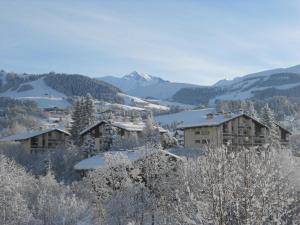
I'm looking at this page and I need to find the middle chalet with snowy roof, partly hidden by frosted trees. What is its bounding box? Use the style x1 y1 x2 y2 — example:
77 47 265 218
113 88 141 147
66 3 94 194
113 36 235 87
80 120 167 150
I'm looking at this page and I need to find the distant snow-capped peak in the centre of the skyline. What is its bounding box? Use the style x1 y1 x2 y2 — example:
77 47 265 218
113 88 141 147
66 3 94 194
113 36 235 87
98 71 199 99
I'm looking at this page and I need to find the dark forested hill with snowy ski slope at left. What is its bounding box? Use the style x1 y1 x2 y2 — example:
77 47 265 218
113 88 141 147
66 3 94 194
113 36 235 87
0 70 123 108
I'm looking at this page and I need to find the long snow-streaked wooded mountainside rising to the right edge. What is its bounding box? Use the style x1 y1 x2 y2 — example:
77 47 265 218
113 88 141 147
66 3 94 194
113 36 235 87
173 65 300 104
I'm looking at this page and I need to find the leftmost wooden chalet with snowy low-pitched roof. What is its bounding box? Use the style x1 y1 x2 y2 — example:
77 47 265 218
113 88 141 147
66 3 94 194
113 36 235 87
0 128 70 152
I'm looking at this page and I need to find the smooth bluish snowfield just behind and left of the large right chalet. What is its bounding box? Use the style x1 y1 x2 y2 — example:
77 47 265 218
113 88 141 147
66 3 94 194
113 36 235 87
155 108 216 125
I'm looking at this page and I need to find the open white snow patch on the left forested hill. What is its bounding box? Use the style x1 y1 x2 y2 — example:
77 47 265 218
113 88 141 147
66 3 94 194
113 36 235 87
0 79 70 108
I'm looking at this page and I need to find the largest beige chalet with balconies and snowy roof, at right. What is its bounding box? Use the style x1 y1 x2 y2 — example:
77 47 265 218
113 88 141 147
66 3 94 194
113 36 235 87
181 113 289 148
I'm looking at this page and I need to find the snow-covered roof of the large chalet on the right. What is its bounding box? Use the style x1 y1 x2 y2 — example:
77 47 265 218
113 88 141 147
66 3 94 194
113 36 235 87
179 113 267 129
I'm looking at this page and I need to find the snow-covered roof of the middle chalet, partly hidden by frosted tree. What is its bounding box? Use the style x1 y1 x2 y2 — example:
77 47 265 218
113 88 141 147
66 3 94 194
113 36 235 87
80 120 167 135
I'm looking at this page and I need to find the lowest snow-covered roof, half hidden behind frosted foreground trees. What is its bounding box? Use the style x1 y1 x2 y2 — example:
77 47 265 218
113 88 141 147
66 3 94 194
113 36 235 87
74 150 181 170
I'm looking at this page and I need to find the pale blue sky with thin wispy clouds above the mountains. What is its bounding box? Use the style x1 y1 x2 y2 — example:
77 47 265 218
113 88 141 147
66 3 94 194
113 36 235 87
0 0 300 85
